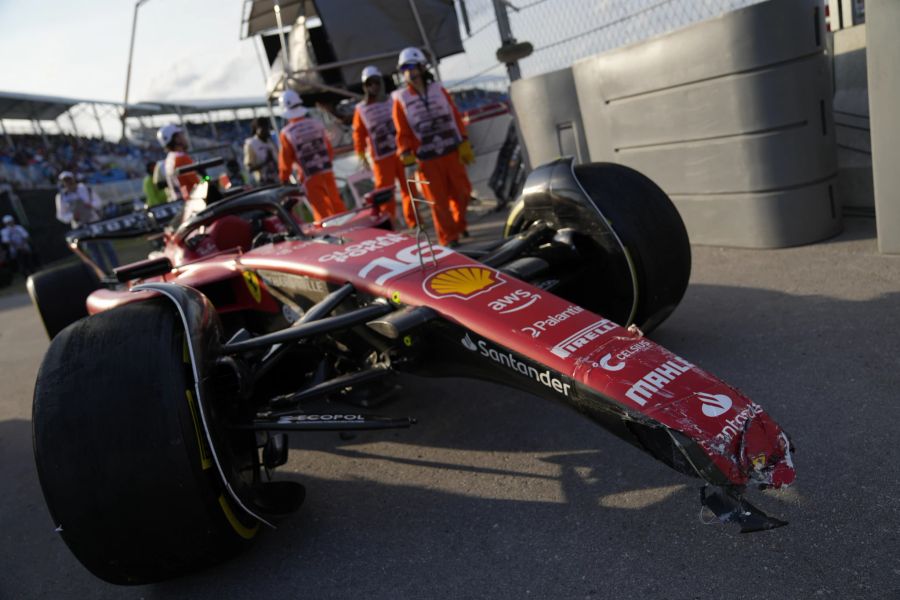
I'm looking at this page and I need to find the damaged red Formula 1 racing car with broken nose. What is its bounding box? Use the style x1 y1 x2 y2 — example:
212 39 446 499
28 159 794 583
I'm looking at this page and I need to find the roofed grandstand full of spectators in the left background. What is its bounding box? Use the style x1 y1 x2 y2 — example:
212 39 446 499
0 92 278 204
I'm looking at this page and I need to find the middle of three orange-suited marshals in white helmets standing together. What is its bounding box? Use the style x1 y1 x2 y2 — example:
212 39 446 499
353 65 416 227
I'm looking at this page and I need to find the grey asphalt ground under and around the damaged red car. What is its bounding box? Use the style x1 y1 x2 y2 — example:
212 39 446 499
0 217 900 599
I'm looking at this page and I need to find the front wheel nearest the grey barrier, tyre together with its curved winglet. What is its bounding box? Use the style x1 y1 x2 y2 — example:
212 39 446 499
504 159 691 333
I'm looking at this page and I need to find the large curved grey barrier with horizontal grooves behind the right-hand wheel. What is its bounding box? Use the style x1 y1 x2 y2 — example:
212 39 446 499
572 0 840 247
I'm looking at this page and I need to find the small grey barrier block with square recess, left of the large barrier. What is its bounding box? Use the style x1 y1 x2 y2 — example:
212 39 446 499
510 69 588 167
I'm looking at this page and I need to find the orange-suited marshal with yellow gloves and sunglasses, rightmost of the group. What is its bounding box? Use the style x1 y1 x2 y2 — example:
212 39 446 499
393 48 475 247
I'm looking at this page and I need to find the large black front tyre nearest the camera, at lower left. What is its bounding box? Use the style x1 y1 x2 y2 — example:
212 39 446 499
33 300 259 584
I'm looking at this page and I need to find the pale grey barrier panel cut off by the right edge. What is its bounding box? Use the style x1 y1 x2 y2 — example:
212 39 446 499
866 0 900 254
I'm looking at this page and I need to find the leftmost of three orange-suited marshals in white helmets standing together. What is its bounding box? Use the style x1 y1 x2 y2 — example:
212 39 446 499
278 90 347 221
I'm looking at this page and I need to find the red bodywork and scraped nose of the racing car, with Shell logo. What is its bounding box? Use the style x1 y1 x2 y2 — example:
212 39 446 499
88 228 794 488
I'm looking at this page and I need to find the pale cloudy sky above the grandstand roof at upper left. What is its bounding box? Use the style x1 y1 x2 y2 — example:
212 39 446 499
0 0 265 102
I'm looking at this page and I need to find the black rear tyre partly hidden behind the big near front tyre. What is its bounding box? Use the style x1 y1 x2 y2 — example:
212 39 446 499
26 262 100 339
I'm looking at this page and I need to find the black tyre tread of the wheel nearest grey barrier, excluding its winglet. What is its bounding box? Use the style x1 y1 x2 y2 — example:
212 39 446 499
504 163 691 333
